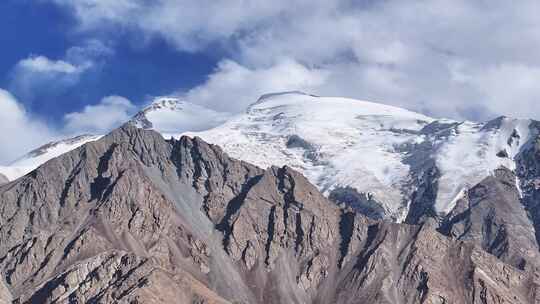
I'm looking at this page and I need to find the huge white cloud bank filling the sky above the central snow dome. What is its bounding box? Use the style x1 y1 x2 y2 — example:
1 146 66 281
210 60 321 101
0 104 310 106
50 0 540 119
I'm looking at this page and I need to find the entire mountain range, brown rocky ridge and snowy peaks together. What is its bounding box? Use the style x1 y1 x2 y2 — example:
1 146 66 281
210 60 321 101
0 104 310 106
0 92 540 304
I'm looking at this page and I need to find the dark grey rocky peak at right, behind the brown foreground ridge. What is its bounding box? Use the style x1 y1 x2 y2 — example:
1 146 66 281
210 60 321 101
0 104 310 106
440 168 540 269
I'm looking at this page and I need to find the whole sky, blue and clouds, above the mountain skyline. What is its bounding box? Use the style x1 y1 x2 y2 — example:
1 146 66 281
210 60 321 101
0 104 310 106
0 0 540 164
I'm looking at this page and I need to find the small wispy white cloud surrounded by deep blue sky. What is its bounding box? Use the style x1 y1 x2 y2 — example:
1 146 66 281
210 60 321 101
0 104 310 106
10 40 113 102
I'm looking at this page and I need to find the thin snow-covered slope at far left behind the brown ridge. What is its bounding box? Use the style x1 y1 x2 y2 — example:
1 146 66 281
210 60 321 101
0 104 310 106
0 135 101 181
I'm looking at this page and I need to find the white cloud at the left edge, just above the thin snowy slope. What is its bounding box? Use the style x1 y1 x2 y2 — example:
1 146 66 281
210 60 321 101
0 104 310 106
0 89 55 164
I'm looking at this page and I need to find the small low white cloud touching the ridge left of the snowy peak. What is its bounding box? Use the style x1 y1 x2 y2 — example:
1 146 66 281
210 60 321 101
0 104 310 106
64 96 136 134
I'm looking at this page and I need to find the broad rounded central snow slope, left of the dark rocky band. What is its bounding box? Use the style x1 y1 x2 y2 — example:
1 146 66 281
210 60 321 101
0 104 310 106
188 92 433 220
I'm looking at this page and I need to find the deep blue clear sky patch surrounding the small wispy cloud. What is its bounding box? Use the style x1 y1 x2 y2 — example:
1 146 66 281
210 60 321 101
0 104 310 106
0 0 219 124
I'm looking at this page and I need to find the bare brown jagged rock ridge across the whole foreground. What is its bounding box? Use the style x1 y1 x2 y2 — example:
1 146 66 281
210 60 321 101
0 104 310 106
0 125 539 303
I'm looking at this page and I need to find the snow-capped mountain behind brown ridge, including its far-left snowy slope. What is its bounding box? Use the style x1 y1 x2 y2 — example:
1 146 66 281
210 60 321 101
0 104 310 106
0 92 539 222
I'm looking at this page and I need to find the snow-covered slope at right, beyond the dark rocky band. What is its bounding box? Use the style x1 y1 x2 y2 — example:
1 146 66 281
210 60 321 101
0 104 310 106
429 117 536 213
